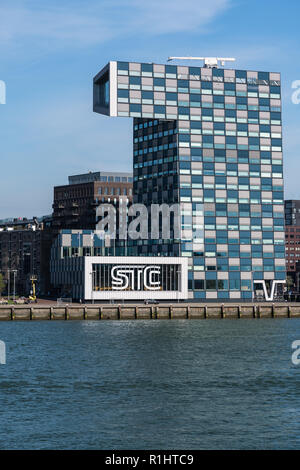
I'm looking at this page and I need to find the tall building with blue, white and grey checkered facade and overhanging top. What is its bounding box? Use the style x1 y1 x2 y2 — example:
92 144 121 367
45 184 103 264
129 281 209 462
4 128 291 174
94 61 286 300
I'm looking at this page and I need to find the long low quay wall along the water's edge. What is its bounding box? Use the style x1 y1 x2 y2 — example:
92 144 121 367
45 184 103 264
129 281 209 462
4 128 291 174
0 303 300 321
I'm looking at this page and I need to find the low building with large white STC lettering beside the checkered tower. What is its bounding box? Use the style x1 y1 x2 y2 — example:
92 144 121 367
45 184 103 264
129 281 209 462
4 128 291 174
50 230 188 302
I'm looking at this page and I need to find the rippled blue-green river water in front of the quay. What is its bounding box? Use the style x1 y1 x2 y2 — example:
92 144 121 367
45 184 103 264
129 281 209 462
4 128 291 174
0 319 300 449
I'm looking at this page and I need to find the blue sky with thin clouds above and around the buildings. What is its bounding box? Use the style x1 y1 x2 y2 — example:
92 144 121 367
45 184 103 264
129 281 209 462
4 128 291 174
0 0 300 218
